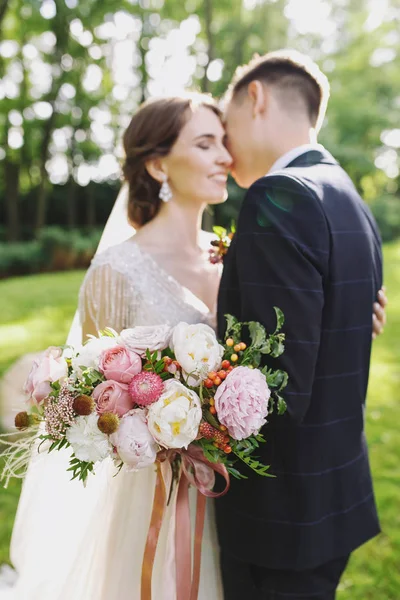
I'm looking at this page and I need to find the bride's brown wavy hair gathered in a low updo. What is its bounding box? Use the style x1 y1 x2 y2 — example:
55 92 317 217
123 94 221 227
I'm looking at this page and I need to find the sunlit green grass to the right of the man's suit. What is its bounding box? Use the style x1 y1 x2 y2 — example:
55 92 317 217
338 243 400 600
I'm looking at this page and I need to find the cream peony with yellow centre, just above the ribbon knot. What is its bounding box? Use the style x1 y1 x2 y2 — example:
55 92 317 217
148 379 202 448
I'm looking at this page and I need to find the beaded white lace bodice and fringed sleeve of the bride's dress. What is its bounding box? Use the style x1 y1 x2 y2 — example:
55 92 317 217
79 239 216 331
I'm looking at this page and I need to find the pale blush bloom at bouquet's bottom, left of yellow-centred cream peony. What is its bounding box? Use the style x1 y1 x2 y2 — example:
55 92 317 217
110 408 158 471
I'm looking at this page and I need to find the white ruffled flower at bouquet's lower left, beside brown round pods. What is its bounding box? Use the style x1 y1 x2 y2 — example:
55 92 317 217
66 413 112 462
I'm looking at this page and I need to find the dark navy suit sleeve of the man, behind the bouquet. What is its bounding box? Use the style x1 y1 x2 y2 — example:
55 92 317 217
237 175 329 422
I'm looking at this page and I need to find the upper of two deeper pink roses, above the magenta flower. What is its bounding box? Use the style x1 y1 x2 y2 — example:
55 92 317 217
99 346 142 384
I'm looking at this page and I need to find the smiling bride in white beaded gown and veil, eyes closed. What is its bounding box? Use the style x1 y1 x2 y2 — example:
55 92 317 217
0 96 231 600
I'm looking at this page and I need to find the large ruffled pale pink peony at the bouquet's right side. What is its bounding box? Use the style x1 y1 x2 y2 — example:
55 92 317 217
215 367 271 440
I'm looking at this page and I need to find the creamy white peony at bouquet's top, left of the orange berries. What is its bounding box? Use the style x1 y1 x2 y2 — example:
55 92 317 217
172 323 224 387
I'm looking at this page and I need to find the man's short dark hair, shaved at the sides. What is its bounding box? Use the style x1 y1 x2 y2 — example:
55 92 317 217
228 50 329 129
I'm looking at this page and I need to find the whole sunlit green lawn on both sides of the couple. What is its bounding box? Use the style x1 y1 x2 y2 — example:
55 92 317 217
0 243 400 600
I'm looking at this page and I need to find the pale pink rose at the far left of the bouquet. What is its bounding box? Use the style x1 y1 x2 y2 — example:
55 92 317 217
24 346 68 405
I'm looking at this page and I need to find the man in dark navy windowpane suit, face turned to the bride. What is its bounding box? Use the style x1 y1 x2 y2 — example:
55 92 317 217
217 51 382 600
